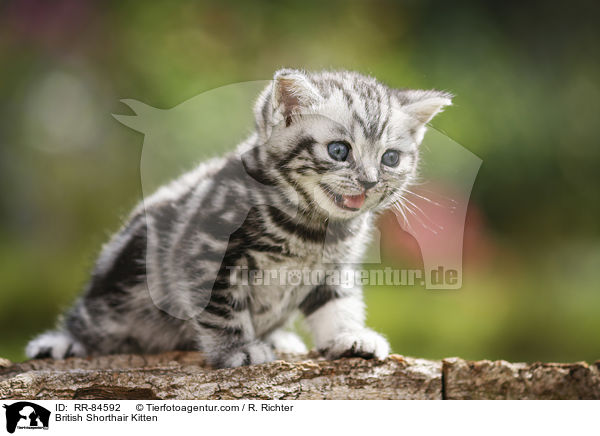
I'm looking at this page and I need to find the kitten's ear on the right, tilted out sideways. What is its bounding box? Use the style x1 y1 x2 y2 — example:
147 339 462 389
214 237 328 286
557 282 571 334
397 90 453 127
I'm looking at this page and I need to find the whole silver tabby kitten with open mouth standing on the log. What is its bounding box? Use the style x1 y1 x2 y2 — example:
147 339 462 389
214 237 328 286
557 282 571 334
26 69 451 367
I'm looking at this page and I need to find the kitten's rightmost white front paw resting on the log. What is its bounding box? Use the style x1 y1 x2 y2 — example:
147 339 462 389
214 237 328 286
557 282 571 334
323 329 390 360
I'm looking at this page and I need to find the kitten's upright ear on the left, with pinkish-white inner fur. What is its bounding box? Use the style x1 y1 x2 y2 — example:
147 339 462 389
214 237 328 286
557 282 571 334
272 69 322 126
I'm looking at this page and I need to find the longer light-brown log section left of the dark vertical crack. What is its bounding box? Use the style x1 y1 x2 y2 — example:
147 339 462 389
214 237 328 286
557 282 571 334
0 352 442 400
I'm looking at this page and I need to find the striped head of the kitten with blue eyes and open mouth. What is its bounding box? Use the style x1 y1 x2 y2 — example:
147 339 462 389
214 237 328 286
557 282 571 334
255 69 451 219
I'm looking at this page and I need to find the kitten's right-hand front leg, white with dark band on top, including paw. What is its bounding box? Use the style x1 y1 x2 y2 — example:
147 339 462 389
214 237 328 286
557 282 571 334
300 285 390 359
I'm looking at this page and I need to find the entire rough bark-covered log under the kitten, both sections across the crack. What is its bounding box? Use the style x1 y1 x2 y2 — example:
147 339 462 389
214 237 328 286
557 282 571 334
0 352 600 400
